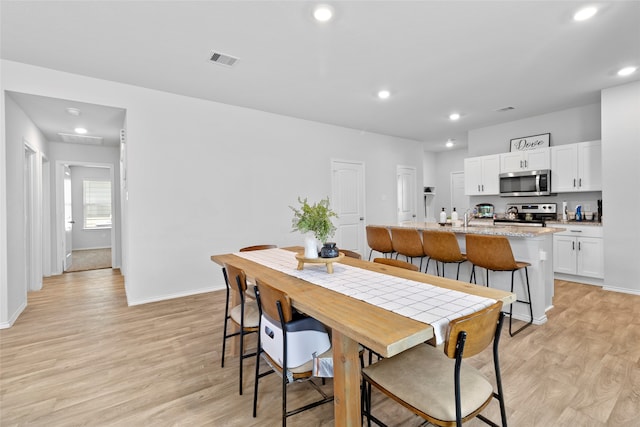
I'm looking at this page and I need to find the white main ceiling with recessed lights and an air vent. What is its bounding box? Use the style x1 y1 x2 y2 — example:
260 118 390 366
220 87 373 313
1 0 640 150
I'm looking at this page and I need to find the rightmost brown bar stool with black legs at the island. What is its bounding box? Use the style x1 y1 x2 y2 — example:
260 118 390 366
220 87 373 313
466 234 533 336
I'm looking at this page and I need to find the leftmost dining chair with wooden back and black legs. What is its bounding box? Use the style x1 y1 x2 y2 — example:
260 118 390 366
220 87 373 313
220 264 260 395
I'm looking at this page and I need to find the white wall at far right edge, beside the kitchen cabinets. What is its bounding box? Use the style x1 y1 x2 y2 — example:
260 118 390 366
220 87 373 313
602 82 640 294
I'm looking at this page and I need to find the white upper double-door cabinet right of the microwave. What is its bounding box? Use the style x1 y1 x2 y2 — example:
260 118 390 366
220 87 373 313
551 141 602 193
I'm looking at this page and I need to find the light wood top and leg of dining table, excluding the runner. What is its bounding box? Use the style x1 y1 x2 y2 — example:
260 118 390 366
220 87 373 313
211 247 515 426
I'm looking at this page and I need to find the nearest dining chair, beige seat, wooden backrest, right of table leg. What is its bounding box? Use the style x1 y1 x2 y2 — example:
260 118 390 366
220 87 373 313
362 301 507 427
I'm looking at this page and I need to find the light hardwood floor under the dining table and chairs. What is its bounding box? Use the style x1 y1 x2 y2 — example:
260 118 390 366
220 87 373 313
0 270 640 427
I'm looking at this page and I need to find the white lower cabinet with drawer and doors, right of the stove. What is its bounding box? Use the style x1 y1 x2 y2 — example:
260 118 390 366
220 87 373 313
553 225 604 279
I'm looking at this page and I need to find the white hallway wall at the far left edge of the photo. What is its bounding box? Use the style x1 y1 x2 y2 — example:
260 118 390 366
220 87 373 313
0 93 47 327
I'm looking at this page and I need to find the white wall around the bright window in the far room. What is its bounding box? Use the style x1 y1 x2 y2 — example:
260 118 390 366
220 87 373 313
70 165 112 250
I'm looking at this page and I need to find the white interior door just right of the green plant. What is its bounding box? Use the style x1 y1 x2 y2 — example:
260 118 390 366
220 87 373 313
331 160 365 255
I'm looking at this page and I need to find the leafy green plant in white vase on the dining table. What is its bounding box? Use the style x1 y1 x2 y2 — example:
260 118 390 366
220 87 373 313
289 197 338 258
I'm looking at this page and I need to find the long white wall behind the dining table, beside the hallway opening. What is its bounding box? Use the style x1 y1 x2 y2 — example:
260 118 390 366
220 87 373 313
2 61 422 314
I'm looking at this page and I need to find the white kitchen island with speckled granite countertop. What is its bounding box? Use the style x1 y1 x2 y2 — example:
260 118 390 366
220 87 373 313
372 222 563 325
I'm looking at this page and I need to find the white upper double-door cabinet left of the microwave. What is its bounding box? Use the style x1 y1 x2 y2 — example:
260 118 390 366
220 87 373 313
464 154 500 196
